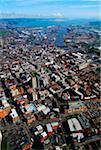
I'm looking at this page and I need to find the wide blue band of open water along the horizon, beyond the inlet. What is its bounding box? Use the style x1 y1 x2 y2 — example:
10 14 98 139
0 18 96 27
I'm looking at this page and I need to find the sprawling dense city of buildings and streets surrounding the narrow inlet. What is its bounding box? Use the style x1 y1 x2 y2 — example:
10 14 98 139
0 20 100 150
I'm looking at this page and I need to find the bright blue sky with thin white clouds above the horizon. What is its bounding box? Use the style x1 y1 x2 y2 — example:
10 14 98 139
0 0 101 19
